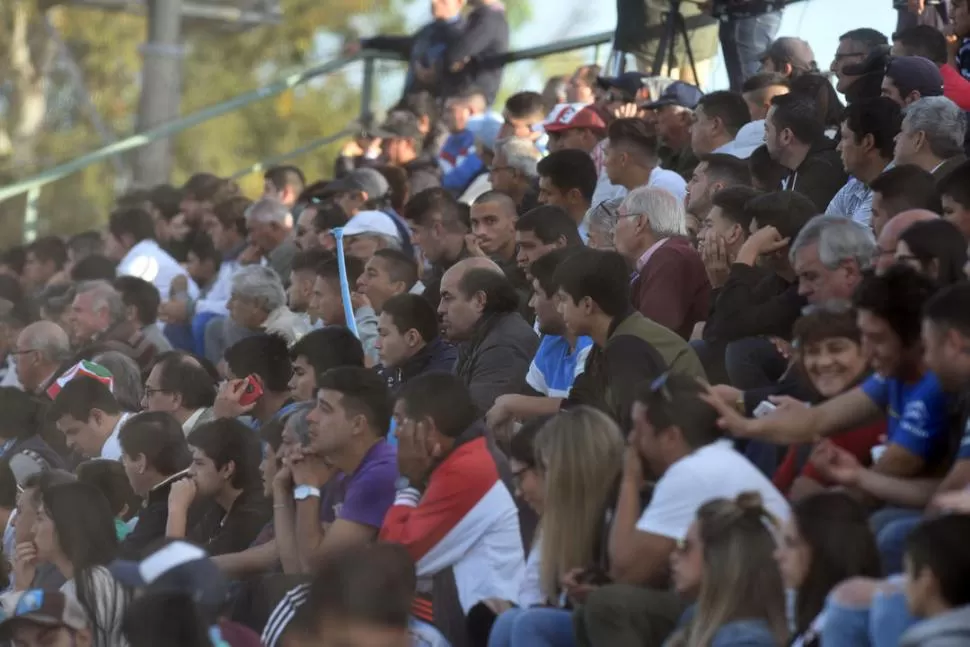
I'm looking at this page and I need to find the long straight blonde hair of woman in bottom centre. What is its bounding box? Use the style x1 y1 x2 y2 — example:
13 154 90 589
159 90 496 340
535 407 624 599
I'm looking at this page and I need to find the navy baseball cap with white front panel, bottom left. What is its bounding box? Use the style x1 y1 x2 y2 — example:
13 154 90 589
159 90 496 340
108 539 229 621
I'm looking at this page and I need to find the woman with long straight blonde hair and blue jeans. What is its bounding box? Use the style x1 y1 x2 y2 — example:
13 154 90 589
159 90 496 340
488 407 624 647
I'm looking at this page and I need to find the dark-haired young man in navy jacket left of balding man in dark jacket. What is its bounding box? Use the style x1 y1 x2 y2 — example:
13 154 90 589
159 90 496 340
377 294 458 393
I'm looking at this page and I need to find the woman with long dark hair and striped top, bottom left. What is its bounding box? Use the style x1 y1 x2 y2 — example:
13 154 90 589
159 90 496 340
34 483 129 647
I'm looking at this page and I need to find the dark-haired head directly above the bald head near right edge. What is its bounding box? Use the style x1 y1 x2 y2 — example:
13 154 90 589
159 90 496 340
869 164 941 238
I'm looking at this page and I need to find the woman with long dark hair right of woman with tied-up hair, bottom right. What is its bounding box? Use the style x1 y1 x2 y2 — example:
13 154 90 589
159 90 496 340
775 492 882 647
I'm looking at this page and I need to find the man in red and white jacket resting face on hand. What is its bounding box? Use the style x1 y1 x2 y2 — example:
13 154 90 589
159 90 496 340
380 373 525 644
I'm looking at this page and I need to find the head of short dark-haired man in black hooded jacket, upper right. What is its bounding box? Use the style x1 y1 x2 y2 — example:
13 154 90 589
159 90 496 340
765 94 825 170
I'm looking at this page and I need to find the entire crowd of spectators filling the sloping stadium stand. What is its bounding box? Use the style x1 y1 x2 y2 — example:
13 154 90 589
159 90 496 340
0 0 970 647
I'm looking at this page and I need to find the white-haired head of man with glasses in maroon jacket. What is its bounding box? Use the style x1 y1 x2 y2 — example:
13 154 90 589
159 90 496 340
616 186 687 266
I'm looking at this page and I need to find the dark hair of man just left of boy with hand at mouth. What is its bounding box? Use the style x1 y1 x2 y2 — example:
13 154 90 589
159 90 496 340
118 411 192 476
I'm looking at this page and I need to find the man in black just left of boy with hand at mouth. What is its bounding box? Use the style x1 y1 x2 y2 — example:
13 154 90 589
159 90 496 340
118 412 193 557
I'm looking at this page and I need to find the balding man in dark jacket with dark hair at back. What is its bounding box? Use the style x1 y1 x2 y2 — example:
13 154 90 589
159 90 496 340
438 258 539 411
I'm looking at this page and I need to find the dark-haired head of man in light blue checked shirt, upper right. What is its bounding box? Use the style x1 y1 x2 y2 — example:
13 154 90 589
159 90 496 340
838 97 903 184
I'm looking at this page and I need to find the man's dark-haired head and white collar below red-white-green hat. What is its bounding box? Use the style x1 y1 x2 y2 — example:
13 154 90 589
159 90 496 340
49 376 131 460
